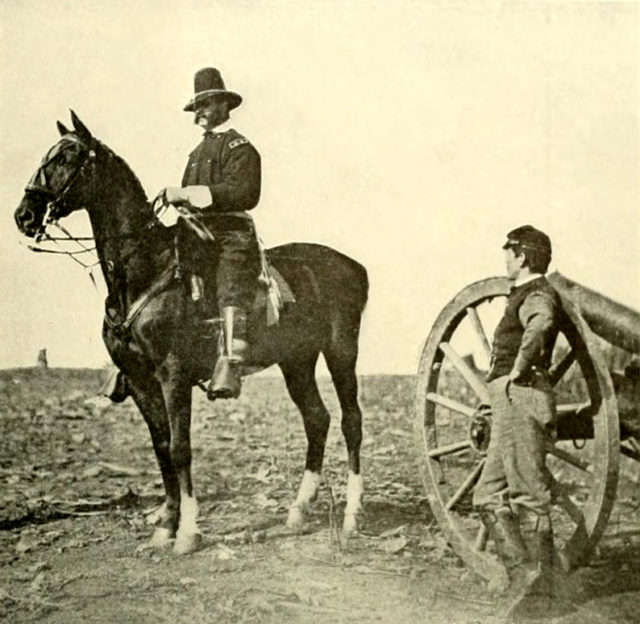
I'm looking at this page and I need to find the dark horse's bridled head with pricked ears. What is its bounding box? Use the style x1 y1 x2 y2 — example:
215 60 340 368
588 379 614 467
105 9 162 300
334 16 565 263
14 111 97 237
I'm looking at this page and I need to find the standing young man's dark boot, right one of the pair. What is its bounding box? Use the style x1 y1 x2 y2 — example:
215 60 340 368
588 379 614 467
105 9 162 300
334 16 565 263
506 515 554 621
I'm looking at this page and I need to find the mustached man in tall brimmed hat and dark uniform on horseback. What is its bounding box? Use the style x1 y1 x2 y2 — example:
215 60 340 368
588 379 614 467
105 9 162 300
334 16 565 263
161 67 261 399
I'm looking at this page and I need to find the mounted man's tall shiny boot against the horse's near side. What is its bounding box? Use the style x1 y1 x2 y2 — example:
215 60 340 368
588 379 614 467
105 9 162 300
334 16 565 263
207 306 249 401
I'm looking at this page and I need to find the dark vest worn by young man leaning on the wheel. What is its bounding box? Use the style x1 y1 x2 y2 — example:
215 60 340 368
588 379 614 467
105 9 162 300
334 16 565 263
487 277 560 381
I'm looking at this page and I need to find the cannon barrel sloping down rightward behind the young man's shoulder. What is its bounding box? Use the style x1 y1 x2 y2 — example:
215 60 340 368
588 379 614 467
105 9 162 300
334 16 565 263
548 272 640 354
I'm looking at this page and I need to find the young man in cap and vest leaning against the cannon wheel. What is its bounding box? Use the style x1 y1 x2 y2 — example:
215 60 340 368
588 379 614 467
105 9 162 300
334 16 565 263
473 225 561 615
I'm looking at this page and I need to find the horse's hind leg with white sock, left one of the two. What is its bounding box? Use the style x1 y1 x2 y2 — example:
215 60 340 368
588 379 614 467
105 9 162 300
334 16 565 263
280 353 330 528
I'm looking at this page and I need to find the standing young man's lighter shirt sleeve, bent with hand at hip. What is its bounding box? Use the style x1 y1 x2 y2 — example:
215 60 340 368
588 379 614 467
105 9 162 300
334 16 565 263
513 292 556 373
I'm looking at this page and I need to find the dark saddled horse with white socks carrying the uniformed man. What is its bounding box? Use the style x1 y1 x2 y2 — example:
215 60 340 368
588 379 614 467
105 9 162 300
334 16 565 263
15 112 368 553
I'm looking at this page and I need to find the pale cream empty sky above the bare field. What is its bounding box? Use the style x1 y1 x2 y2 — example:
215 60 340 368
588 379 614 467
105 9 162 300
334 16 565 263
0 0 640 373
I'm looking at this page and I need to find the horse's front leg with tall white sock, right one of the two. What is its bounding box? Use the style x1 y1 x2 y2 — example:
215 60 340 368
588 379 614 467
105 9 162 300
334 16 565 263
162 360 202 554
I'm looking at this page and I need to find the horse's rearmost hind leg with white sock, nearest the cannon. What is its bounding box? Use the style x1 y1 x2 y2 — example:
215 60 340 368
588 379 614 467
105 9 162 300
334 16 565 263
324 324 363 535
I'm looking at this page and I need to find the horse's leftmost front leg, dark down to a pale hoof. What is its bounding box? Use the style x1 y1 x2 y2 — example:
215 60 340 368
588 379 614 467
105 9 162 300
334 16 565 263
130 375 180 547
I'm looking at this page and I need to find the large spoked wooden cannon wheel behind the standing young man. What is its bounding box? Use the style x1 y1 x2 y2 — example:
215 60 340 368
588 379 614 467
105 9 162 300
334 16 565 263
414 277 620 580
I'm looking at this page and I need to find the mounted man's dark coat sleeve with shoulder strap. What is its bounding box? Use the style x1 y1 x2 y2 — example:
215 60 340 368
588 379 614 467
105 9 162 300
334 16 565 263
209 133 262 212
